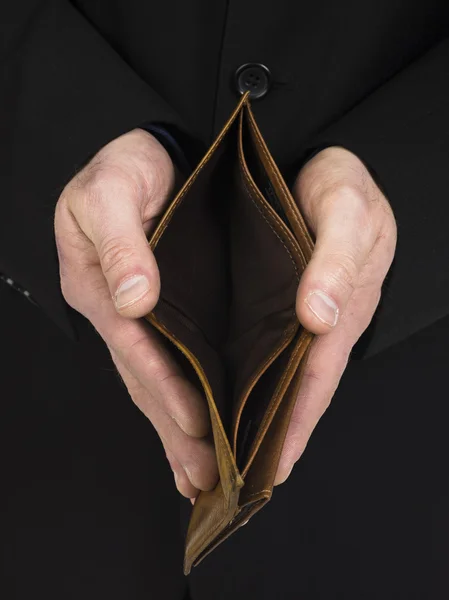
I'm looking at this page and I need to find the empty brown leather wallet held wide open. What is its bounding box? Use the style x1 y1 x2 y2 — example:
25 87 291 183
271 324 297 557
145 92 313 575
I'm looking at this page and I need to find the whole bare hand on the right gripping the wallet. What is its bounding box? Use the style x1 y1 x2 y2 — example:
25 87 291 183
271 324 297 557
275 147 396 485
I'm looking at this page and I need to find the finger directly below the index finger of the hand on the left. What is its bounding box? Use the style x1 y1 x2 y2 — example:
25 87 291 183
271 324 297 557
111 352 218 491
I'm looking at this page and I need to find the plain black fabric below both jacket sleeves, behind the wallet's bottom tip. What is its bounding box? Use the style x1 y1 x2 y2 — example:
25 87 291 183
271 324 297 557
0 274 449 600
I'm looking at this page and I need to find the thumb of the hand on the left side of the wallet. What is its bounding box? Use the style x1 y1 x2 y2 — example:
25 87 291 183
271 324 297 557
71 177 160 318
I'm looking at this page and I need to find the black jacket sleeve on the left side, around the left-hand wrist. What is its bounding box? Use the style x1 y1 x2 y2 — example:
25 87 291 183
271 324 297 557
0 0 191 335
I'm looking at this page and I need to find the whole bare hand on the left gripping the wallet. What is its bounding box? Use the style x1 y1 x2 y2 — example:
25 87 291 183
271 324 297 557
55 129 218 498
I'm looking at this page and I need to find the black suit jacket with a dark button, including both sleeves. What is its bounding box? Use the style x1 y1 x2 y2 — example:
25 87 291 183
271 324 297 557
0 0 449 355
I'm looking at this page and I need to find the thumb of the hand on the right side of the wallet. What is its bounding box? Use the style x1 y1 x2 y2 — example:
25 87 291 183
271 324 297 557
296 187 378 334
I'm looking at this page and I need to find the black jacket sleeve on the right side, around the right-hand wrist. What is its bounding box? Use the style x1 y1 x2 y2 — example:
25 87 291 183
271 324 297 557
298 39 449 357
